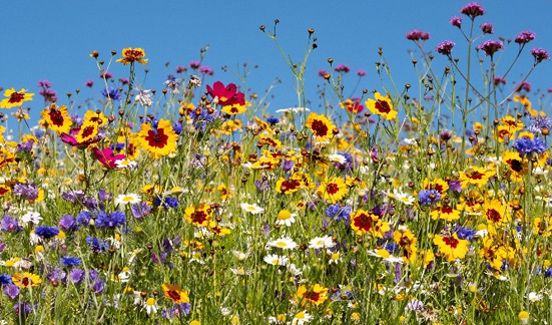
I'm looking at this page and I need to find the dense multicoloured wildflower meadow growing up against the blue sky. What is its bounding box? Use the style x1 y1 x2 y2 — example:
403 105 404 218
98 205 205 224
0 3 552 325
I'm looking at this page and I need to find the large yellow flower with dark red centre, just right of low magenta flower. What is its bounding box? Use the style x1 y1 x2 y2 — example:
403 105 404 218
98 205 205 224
138 119 178 159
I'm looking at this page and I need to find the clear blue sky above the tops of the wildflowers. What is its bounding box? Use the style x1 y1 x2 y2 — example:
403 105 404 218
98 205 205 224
0 0 552 123
